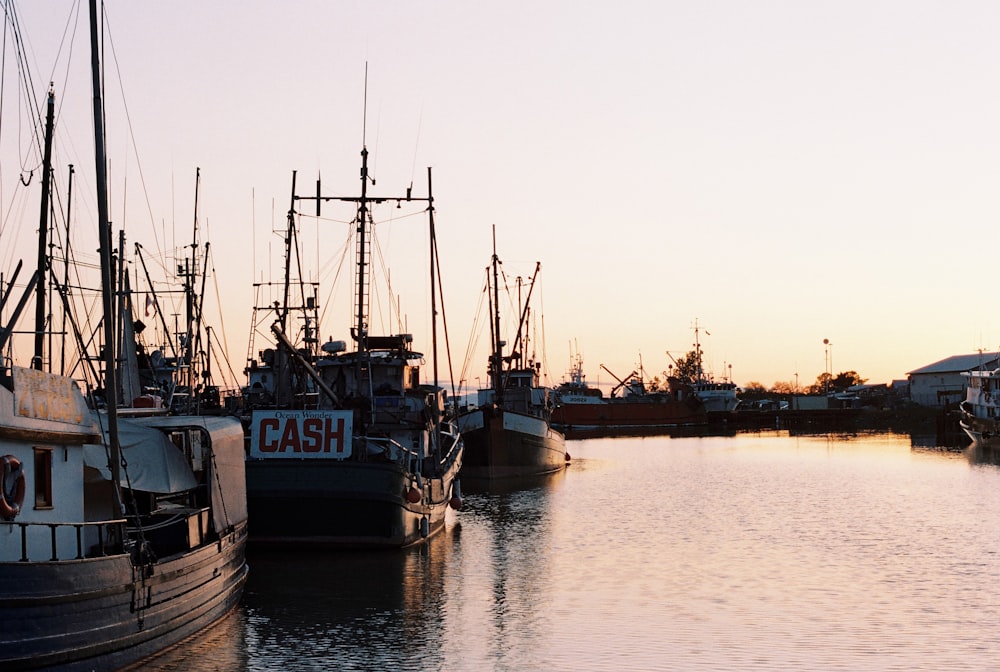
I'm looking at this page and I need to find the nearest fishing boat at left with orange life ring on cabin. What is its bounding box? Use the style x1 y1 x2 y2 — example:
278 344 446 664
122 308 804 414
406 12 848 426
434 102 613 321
0 0 248 671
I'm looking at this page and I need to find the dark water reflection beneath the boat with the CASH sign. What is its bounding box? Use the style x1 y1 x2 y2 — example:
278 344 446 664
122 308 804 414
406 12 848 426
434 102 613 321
243 529 452 669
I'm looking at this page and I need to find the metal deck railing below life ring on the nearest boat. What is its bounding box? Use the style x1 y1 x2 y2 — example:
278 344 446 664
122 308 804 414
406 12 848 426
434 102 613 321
4 519 125 562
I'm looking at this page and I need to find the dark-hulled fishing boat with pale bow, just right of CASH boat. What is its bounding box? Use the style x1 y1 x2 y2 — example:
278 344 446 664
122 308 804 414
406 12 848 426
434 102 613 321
458 229 567 481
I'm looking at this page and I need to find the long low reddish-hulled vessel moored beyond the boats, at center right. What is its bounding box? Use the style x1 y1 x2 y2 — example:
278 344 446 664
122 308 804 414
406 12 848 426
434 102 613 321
552 355 707 438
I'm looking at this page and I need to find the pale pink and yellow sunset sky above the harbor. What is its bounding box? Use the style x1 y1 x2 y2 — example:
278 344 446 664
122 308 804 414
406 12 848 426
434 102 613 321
0 0 1000 394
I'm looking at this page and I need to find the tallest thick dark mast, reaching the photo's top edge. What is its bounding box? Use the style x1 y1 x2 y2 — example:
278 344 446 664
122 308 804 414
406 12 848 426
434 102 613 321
90 0 123 516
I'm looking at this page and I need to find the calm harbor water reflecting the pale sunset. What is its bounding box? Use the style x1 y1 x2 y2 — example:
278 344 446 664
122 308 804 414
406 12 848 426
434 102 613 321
139 432 1000 672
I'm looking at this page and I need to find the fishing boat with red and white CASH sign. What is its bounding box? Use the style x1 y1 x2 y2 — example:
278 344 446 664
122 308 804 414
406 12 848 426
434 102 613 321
244 146 464 548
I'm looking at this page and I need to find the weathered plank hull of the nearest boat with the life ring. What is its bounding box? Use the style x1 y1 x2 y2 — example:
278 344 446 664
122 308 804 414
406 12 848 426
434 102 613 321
0 523 247 672
